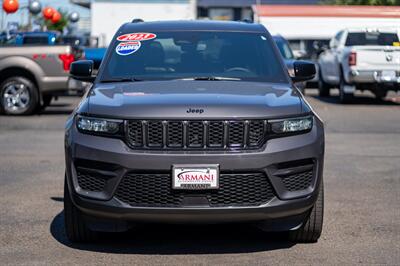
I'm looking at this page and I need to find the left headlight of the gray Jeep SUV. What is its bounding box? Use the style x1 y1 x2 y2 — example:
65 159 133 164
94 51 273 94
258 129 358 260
76 116 123 135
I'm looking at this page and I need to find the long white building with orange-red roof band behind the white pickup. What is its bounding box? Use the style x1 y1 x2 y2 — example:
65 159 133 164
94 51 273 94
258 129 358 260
253 5 400 59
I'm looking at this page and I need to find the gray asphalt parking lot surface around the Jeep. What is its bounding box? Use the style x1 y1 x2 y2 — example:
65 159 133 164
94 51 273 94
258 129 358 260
0 90 400 265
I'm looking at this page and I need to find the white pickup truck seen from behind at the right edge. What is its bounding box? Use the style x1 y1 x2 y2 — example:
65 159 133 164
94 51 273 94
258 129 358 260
318 29 400 103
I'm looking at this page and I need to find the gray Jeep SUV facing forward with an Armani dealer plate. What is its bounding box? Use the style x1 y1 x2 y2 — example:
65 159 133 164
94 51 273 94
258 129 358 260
64 21 324 242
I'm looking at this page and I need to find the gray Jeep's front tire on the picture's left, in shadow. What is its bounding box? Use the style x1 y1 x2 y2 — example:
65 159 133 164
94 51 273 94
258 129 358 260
64 179 98 242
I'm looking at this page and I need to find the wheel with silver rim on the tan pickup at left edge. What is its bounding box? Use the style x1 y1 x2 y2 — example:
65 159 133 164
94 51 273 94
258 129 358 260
0 76 39 115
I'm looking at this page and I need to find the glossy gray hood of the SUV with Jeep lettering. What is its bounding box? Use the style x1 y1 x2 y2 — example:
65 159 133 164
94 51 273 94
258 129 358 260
85 80 304 119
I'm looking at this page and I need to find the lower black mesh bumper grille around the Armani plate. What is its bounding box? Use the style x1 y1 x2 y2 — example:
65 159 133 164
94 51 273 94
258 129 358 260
115 173 274 207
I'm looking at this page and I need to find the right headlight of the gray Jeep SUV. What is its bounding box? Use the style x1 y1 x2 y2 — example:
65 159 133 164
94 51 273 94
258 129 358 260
269 116 313 134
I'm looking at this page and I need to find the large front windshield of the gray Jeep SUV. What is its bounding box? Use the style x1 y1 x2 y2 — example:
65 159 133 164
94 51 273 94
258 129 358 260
101 31 288 83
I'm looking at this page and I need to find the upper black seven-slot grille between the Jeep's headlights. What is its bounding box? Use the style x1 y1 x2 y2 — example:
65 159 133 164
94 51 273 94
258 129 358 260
126 120 267 150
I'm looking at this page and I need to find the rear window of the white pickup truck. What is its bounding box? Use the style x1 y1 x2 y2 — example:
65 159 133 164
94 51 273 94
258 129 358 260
346 32 399 46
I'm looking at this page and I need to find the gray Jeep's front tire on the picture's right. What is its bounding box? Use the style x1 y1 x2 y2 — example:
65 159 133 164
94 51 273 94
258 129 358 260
289 181 324 243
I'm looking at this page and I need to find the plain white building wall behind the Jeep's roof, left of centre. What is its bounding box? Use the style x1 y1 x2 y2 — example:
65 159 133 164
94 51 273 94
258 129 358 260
91 0 195 46
